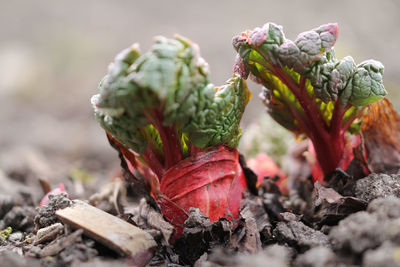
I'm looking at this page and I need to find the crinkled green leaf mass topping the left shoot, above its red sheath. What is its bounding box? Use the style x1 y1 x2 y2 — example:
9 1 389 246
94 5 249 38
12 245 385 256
92 34 250 158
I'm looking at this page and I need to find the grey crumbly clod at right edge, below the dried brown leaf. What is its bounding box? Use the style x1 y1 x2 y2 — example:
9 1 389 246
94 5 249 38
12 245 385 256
355 173 400 202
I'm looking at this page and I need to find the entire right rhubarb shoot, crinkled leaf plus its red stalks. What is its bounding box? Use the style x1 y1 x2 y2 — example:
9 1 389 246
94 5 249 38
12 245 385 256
233 23 387 182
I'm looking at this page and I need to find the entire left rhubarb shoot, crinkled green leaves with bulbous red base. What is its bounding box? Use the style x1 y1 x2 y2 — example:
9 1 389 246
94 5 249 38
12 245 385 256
92 37 251 235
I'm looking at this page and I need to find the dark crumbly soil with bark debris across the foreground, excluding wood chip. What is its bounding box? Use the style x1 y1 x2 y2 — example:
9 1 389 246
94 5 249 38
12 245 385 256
0 162 400 267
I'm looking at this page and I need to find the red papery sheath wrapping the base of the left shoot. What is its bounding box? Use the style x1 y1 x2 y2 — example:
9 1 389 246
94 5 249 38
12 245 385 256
157 146 246 236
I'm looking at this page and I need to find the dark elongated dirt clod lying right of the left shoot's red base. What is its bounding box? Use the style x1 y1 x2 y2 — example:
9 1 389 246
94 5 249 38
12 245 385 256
273 221 329 252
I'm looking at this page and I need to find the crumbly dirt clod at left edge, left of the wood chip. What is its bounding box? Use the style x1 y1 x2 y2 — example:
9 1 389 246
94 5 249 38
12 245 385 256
0 206 36 232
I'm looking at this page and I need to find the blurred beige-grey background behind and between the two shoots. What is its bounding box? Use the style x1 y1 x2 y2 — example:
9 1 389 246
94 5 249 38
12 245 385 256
0 0 400 188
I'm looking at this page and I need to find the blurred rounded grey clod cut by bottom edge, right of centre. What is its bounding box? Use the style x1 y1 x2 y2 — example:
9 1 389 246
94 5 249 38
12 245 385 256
295 247 338 267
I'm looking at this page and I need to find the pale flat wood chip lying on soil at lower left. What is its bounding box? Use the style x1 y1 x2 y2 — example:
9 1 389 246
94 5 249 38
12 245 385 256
56 200 157 257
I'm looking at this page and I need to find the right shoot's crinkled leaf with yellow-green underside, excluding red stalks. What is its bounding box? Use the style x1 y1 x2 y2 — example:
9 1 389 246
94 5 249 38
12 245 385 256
233 23 387 137
